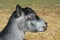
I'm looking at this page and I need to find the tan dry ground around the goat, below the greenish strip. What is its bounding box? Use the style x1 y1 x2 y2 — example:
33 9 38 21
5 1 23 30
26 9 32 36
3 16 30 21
0 7 60 40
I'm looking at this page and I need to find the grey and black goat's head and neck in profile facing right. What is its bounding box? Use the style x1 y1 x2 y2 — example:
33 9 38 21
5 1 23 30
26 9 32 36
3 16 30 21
0 5 47 40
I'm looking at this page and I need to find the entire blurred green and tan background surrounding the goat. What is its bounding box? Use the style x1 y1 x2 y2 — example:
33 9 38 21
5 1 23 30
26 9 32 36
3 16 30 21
0 0 60 40
